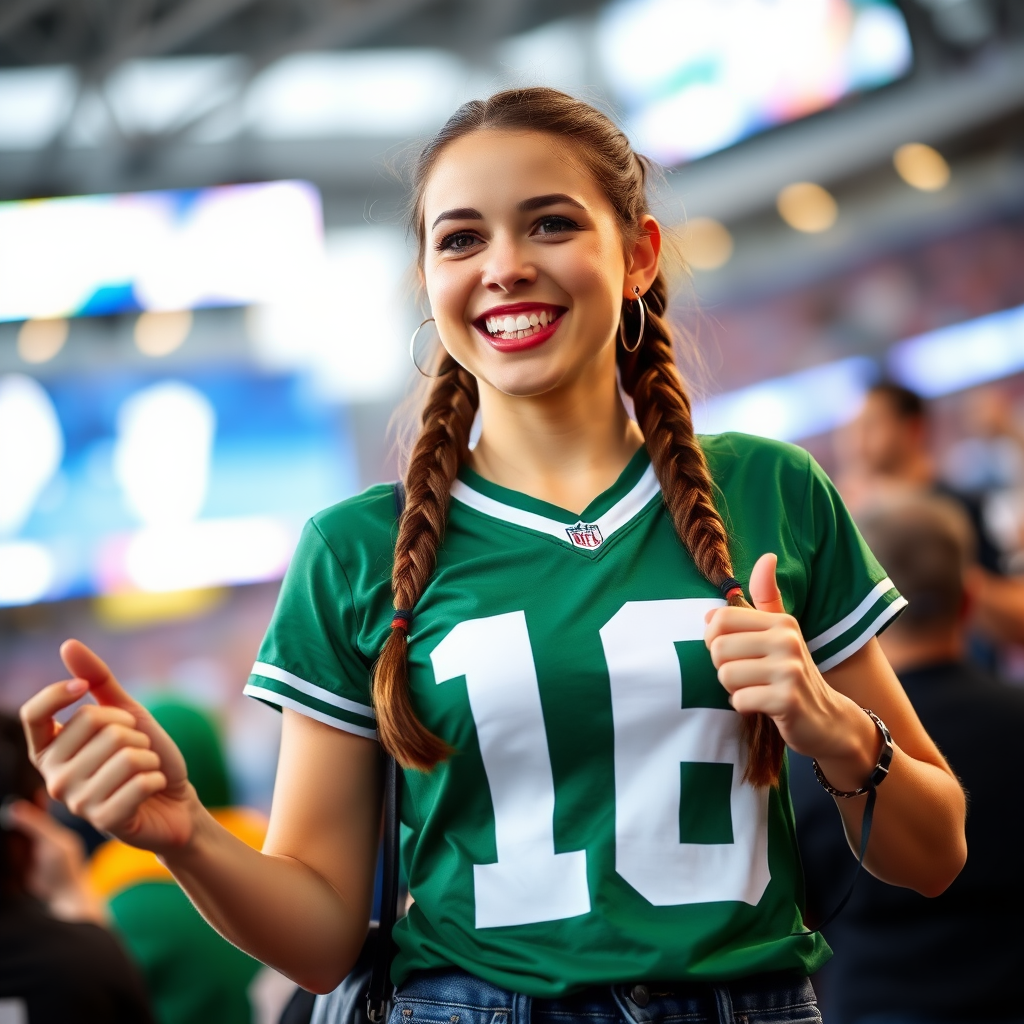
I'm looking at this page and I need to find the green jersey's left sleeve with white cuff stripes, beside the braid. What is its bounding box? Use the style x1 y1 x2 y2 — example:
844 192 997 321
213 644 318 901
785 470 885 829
244 520 377 739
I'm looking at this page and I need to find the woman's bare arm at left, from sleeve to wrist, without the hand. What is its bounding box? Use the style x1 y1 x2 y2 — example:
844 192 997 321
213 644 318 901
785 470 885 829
161 709 381 992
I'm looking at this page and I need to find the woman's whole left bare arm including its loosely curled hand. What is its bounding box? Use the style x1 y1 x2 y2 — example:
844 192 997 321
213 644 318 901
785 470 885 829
22 641 381 991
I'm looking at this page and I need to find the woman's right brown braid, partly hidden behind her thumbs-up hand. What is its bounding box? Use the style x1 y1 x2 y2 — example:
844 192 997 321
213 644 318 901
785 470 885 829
618 273 783 786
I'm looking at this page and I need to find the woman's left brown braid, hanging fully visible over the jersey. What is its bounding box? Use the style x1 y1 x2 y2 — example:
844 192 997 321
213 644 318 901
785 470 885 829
373 353 479 771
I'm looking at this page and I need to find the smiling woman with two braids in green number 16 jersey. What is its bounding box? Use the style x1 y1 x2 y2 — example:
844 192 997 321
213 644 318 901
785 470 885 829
24 89 966 1022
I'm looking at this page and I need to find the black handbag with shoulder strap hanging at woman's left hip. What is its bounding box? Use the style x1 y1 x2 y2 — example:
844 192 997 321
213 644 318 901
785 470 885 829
279 482 406 1024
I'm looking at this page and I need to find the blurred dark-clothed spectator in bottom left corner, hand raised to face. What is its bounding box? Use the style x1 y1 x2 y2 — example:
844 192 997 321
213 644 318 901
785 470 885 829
0 714 153 1024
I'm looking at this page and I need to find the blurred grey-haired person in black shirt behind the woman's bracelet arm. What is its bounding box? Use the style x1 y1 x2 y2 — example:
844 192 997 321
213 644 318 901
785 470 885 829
791 496 1024 1024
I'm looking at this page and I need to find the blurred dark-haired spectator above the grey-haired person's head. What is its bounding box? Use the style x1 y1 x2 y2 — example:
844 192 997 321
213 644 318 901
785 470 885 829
837 383 1024 651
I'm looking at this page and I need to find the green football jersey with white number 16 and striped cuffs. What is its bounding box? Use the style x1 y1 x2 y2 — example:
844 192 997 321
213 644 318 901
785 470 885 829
246 434 906 997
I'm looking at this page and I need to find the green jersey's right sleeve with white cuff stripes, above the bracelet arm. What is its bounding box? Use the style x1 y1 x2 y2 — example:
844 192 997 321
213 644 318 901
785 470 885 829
797 456 906 672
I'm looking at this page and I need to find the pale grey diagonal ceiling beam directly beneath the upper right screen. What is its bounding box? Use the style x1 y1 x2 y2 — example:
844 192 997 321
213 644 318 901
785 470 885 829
663 44 1024 222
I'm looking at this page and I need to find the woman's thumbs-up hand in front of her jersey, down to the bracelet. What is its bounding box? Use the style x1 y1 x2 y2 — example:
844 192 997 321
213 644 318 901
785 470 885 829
705 554 880 790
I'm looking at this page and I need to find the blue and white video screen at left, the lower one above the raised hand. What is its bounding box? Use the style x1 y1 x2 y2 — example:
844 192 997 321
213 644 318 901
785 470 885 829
0 367 358 605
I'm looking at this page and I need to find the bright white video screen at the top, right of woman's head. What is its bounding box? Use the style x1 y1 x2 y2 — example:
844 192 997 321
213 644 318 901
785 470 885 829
598 0 912 166
